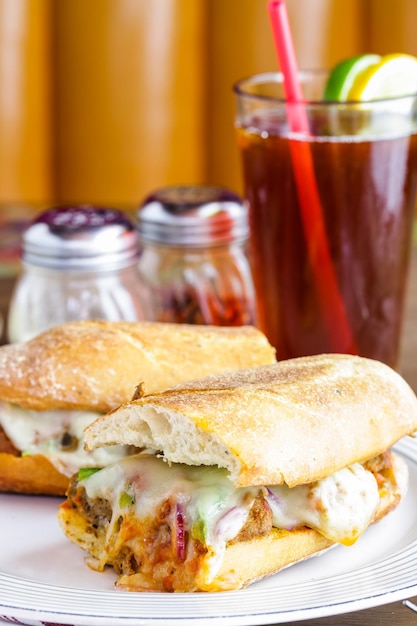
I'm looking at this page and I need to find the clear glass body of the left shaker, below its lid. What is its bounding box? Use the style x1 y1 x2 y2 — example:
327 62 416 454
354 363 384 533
8 264 151 342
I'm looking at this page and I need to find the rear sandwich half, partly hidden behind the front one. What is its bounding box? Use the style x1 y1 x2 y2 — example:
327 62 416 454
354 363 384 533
0 321 275 495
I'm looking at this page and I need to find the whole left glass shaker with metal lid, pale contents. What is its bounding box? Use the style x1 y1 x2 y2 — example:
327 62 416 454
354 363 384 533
8 205 149 342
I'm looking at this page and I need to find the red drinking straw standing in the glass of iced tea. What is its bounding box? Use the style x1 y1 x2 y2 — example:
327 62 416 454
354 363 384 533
268 0 358 354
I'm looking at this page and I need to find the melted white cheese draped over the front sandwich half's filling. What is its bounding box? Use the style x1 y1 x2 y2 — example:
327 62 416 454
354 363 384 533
81 454 379 576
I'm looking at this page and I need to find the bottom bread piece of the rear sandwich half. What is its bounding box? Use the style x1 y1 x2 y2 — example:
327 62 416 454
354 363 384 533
0 452 69 496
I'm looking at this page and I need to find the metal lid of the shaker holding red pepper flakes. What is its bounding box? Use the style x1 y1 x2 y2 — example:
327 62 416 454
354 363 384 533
137 185 249 247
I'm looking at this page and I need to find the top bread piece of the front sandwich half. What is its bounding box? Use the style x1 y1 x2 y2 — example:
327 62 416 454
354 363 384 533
85 354 417 487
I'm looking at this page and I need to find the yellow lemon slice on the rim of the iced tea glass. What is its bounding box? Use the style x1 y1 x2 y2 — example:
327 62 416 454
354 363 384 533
346 54 417 102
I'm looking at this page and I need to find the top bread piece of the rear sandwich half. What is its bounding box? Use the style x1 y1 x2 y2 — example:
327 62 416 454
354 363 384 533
0 321 275 412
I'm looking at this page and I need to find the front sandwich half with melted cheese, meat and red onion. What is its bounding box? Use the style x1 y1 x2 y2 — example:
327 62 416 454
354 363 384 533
58 354 417 592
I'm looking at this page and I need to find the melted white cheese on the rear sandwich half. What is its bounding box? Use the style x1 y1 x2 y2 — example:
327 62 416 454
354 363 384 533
0 402 132 476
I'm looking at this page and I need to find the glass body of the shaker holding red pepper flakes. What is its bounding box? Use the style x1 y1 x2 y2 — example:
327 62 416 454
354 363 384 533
139 243 256 326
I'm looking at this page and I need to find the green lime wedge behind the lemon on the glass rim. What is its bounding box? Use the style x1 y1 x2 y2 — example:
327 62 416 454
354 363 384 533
323 54 381 101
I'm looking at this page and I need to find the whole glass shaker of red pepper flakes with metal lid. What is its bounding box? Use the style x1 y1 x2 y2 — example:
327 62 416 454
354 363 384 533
137 185 256 326
